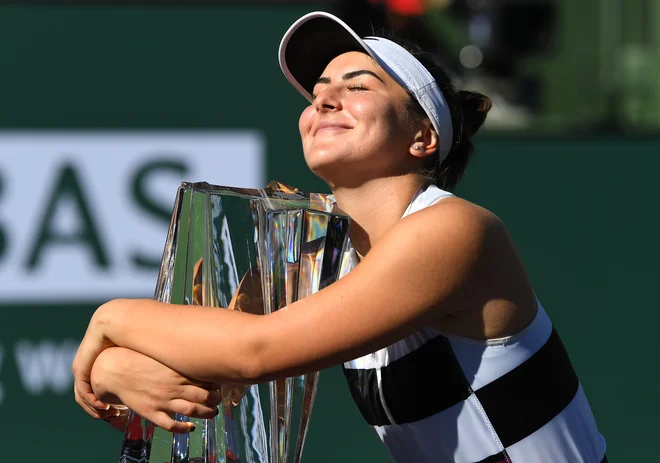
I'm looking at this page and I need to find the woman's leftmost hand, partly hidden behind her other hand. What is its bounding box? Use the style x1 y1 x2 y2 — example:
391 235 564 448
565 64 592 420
72 303 121 419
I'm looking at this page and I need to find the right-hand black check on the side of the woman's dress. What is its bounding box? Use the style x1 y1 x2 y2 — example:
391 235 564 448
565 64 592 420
475 328 579 447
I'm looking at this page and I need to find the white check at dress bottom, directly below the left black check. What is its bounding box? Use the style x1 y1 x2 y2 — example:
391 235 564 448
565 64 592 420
375 400 500 463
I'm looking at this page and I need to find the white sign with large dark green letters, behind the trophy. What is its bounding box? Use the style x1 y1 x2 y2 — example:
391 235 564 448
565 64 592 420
0 131 265 302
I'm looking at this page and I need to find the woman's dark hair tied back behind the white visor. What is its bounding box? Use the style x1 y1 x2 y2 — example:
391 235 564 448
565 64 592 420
380 31 493 191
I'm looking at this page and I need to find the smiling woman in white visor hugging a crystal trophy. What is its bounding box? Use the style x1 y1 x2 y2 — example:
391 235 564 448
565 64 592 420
74 13 606 463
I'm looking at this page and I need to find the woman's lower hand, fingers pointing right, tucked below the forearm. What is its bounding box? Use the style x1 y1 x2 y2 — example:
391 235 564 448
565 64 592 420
83 347 222 433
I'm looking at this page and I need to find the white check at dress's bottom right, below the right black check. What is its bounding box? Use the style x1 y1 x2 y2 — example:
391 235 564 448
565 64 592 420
507 386 605 463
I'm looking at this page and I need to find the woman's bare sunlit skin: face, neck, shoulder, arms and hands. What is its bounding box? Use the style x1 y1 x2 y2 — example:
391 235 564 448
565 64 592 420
73 52 537 432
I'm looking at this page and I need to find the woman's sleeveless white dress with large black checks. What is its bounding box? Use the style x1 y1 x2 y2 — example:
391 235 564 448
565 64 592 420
344 187 606 463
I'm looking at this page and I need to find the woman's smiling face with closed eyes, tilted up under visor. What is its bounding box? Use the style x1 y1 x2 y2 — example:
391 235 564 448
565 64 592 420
299 52 415 185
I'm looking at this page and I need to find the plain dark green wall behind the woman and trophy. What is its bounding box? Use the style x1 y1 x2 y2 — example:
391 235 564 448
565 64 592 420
0 2 660 463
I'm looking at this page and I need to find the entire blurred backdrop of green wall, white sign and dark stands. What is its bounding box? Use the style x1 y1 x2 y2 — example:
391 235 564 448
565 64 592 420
0 0 660 463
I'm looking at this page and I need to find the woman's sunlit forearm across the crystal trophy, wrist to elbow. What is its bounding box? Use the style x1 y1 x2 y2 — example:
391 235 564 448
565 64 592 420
94 299 263 383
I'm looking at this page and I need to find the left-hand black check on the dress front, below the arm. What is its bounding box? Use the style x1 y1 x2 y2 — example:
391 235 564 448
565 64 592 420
344 336 470 426
